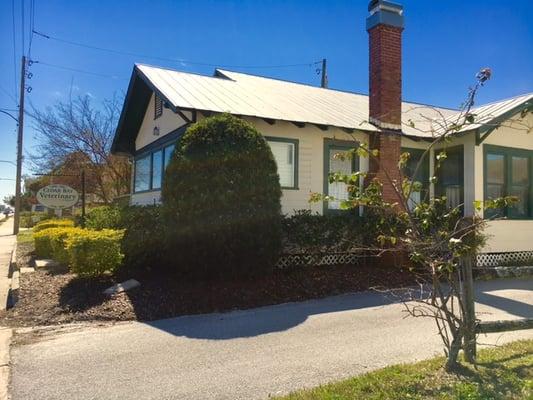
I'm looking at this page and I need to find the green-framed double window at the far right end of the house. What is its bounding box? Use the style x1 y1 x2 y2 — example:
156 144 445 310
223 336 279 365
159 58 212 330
485 146 533 219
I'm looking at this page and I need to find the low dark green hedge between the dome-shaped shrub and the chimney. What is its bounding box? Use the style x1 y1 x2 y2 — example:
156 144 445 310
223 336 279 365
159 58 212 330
282 210 364 253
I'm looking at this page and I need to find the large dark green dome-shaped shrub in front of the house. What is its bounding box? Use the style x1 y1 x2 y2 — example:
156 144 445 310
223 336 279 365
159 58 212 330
162 114 281 278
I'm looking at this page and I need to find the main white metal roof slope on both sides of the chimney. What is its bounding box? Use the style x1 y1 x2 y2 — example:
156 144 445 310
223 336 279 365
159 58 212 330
136 64 457 137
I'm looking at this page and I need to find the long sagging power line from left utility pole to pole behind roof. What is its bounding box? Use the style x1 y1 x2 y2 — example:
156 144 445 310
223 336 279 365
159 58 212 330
33 30 322 69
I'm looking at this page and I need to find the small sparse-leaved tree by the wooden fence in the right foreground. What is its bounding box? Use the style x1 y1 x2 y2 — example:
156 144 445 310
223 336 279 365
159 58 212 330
311 69 532 369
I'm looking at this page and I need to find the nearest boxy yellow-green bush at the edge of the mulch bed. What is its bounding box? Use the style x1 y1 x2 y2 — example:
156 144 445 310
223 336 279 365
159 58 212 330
65 229 124 276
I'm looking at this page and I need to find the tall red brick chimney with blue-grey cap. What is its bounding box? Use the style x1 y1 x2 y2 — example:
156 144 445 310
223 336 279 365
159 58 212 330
366 0 403 202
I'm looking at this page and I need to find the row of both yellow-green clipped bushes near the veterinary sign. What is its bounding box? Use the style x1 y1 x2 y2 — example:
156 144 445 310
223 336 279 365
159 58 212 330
34 226 124 276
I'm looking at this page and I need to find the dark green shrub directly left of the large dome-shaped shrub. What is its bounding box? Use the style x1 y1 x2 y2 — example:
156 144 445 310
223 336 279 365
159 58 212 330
119 206 164 272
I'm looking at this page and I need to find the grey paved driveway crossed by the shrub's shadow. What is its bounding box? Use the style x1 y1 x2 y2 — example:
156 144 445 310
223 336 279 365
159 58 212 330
11 280 533 400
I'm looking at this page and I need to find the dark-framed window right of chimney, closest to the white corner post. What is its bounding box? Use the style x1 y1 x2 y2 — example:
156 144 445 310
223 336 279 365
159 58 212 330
435 146 464 207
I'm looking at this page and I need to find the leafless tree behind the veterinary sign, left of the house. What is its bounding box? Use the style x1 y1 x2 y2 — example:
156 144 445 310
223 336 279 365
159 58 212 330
31 96 130 203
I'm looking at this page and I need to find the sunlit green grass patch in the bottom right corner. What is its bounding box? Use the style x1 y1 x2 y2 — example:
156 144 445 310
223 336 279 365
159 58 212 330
277 340 533 400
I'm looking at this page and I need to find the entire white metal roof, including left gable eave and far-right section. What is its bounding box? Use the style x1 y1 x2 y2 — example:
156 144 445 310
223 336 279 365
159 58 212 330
120 64 533 145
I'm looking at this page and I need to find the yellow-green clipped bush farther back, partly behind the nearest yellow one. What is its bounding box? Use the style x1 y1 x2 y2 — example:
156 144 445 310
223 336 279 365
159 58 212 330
33 226 82 264
